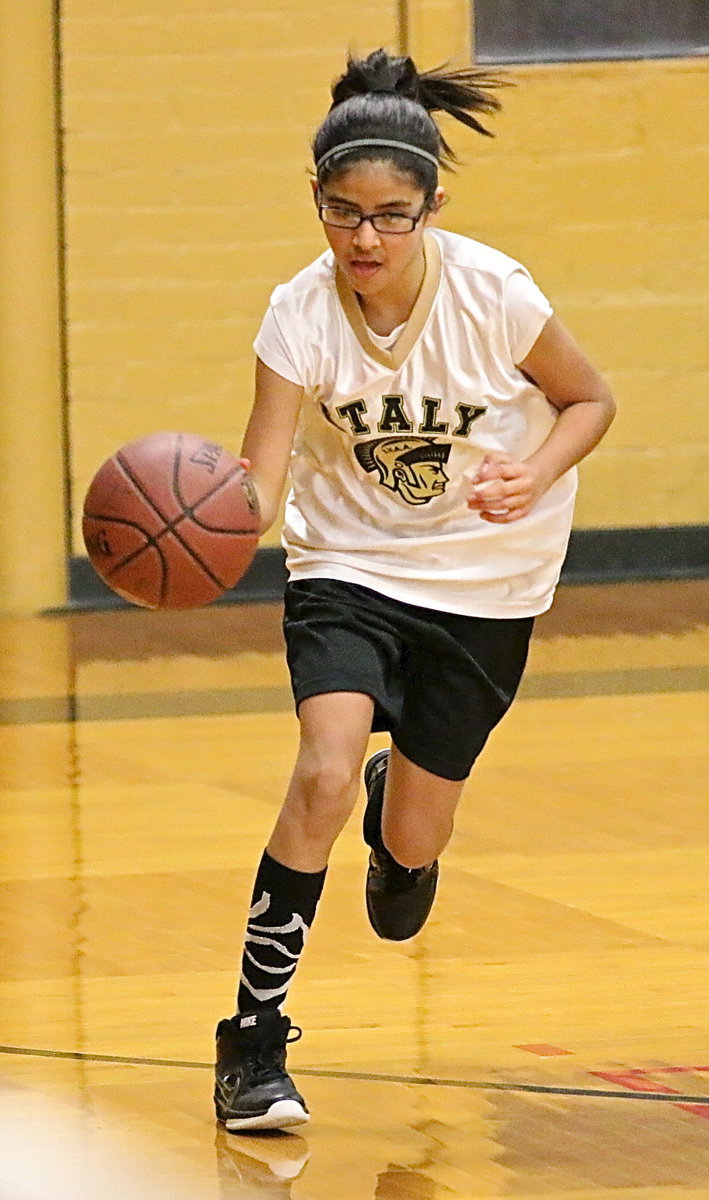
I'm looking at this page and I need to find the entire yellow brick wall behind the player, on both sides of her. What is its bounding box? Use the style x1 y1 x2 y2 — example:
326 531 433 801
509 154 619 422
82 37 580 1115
61 0 709 553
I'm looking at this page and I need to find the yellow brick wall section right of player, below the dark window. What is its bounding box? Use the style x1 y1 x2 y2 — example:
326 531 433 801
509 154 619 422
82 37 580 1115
445 59 709 528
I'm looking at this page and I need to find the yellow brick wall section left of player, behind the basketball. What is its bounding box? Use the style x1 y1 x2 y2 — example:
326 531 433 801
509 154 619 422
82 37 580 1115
61 0 397 553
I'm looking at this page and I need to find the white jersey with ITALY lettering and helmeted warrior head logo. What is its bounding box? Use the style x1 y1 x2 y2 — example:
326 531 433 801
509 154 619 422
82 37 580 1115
254 230 576 617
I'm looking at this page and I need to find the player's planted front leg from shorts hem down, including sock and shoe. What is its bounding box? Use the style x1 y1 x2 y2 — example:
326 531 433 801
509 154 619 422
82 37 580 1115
215 692 373 1132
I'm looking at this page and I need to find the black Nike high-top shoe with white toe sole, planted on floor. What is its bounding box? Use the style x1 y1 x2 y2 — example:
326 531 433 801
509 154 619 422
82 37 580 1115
215 1008 310 1132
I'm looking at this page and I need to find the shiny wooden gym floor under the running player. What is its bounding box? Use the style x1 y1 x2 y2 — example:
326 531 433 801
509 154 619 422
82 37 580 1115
0 582 709 1200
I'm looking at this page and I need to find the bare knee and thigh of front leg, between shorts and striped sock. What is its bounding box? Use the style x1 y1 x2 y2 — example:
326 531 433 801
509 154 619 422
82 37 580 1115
268 691 374 871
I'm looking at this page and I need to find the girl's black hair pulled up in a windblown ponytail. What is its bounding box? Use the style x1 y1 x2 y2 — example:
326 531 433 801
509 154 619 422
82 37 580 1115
312 49 506 197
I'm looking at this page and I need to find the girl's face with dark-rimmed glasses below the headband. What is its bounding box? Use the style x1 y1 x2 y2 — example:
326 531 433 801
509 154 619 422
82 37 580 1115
316 161 443 304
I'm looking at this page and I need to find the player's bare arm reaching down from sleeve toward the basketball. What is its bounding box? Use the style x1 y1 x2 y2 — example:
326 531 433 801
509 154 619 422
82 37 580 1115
241 358 302 533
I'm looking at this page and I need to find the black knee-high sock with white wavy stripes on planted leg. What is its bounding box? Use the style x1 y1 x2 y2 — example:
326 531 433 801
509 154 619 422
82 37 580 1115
236 851 325 1013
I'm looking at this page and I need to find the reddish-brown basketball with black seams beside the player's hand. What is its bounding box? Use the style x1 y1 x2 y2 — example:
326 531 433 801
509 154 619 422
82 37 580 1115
83 433 259 608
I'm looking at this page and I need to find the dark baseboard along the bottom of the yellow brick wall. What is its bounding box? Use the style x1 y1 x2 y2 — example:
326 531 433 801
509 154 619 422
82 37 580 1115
67 526 709 611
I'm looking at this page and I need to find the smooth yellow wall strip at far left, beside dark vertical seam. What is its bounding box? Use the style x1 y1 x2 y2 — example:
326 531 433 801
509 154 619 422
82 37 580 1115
0 0 66 611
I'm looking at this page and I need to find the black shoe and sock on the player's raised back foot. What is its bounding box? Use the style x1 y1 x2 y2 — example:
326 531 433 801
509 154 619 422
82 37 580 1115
363 750 438 942
